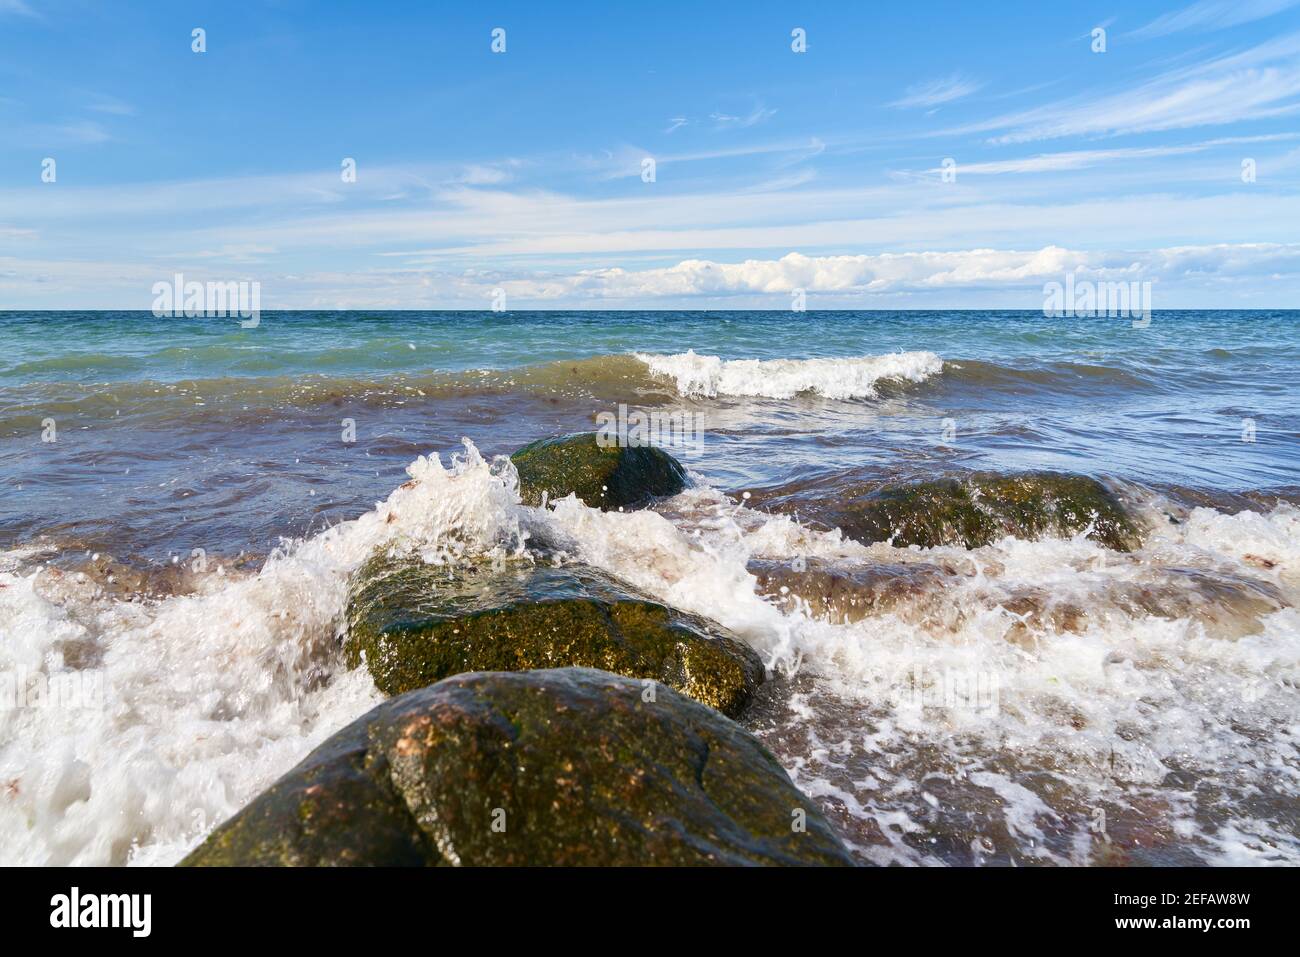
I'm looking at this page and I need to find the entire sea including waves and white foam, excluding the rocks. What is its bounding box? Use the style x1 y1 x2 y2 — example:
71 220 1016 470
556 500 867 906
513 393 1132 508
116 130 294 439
0 311 1300 865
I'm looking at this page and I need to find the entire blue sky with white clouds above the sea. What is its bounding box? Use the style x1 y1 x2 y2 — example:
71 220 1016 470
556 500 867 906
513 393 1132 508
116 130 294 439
0 0 1300 309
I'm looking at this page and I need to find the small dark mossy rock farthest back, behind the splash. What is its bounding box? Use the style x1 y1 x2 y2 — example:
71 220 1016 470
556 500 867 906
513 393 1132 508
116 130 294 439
510 432 686 508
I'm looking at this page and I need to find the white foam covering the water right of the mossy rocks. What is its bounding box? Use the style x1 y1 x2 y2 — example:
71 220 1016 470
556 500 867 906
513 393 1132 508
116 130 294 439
530 489 1300 863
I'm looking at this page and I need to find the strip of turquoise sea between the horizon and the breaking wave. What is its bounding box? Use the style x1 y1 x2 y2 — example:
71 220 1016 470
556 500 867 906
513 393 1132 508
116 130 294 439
0 311 1300 394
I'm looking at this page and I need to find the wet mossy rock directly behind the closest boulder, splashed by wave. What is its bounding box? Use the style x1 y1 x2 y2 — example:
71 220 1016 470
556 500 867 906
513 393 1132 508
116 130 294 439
345 555 763 716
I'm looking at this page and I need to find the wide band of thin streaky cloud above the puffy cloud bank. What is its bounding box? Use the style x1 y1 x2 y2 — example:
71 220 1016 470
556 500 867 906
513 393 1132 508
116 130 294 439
12 153 1300 269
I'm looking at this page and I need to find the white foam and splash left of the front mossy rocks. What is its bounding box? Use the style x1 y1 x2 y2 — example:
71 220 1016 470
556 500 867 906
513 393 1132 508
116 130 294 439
0 447 523 865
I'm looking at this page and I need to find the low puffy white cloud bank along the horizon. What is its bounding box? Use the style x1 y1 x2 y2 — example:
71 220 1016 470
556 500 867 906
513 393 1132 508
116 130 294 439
0 243 1300 308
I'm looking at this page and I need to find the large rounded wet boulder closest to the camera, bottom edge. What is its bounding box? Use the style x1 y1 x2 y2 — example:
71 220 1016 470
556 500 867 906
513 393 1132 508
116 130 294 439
182 668 853 866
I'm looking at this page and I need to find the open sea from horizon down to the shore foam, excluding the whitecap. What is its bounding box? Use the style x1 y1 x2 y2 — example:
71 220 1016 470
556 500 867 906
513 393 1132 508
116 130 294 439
0 311 1300 558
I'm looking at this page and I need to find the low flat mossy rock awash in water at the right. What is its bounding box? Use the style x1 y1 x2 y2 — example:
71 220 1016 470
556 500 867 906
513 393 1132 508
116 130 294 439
757 472 1140 551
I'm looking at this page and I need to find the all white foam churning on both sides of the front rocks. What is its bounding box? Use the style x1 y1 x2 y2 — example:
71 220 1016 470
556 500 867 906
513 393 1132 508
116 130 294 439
0 443 1300 863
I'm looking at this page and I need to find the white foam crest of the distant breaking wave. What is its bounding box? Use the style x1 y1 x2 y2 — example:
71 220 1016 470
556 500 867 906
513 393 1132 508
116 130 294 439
633 350 944 399
